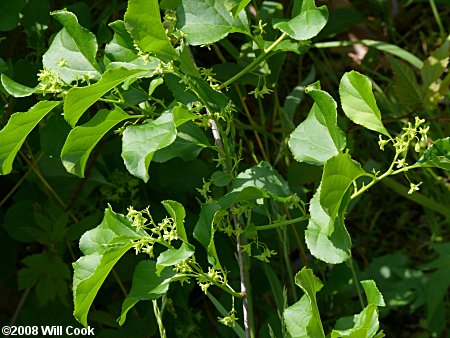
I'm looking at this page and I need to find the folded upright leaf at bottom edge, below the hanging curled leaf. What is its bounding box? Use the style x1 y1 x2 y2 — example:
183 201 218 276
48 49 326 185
283 268 325 338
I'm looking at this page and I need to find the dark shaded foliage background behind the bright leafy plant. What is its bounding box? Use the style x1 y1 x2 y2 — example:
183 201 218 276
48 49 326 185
0 0 450 337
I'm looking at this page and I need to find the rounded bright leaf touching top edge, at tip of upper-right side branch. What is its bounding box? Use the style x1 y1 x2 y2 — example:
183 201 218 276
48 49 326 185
273 0 328 40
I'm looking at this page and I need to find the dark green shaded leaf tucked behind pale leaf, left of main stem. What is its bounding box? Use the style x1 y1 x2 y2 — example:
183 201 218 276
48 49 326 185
153 122 210 162
